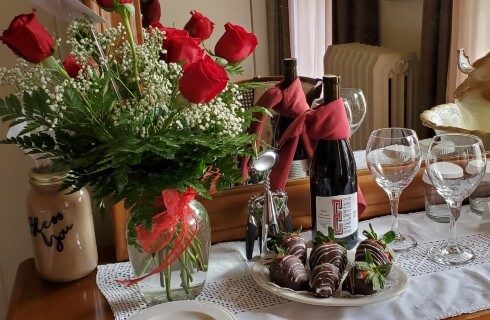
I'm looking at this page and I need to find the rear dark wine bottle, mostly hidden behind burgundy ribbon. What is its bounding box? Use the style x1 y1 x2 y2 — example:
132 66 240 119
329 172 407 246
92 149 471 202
274 58 309 178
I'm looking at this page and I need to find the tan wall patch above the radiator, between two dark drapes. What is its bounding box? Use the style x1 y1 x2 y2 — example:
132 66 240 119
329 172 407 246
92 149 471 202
379 0 423 58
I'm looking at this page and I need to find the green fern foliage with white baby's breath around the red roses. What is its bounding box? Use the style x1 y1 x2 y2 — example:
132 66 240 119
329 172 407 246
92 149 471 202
0 22 264 226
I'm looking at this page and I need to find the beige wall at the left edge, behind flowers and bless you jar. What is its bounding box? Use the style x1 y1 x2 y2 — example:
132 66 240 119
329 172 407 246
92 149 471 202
0 1 56 319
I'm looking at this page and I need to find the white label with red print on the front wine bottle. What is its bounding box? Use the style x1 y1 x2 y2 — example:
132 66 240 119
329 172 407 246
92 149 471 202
316 192 358 238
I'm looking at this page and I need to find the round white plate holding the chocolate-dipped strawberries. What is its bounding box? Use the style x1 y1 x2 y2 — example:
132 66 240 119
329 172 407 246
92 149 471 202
252 259 408 307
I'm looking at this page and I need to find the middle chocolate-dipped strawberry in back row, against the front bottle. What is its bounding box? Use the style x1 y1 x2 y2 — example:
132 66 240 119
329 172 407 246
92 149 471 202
309 227 347 277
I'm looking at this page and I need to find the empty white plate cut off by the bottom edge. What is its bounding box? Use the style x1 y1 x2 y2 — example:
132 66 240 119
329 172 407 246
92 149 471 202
130 300 236 320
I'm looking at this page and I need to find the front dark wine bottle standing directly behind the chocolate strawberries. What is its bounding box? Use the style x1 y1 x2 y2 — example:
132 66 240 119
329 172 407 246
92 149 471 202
310 75 358 249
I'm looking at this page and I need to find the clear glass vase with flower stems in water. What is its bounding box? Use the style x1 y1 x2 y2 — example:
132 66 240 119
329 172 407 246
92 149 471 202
128 200 211 304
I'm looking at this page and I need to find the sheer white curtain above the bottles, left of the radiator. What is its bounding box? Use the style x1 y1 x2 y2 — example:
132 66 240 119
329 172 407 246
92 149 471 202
289 0 332 78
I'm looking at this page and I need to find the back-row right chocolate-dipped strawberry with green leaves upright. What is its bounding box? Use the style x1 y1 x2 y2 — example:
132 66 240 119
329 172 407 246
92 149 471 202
355 224 395 275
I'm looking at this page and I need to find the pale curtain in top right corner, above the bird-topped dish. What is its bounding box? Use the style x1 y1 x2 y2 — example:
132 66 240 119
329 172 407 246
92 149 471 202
446 0 490 101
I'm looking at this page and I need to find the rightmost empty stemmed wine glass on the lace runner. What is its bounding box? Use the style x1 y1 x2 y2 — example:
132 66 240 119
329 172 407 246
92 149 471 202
427 134 487 265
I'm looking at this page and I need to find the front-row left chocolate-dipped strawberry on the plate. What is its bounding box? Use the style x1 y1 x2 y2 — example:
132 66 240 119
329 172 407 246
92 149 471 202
269 254 308 291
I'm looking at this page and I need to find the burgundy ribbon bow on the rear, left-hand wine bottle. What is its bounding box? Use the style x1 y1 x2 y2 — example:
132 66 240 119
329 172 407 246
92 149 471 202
242 78 314 180
